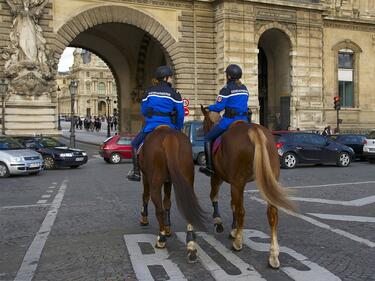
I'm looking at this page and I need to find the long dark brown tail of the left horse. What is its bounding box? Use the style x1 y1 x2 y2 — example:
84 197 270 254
163 134 206 229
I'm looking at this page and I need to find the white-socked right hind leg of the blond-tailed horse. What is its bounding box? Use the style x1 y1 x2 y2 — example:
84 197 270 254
267 204 280 269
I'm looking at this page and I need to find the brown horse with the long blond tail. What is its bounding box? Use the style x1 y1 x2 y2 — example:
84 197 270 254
201 106 295 268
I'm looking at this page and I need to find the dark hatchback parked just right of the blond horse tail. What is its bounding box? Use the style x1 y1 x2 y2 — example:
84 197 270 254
273 131 354 169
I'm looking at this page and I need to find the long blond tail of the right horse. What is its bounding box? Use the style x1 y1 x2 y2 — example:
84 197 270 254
248 126 296 211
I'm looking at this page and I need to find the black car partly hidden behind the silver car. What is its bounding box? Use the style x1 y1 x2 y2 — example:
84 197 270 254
16 137 87 169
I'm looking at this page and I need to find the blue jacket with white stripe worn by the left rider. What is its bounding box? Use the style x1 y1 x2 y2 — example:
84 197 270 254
141 81 184 133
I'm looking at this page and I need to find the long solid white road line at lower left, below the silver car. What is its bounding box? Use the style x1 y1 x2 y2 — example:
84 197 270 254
14 180 67 281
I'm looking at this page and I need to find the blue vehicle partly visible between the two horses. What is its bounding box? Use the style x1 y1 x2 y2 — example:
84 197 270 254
183 121 206 166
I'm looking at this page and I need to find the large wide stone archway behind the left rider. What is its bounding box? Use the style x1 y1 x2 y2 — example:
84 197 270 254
56 6 177 132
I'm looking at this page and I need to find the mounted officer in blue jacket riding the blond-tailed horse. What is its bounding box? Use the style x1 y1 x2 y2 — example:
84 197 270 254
199 64 249 176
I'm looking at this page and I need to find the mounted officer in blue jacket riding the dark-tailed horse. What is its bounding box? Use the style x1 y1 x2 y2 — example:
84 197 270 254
127 66 184 181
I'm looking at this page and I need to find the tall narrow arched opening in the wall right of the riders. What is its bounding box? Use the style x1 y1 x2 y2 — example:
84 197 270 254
257 27 294 130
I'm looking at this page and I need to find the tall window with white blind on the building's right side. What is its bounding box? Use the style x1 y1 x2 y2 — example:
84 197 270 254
338 49 355 107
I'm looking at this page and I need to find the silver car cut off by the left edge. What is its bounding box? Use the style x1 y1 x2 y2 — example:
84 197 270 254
0 137 43 178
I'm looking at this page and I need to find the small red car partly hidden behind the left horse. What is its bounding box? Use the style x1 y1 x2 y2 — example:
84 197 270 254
99 135 133 164
